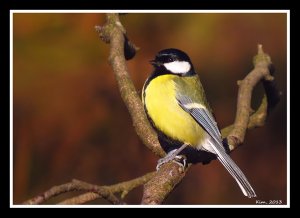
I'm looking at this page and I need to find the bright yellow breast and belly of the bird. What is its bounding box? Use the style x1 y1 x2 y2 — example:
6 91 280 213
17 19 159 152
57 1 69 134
143 75 205 146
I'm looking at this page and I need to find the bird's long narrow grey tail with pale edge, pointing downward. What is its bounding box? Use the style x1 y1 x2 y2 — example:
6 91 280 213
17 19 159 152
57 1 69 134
210 140 256 198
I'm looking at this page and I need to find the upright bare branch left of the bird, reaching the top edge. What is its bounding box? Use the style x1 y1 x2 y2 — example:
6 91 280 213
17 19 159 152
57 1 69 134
96 14 165 157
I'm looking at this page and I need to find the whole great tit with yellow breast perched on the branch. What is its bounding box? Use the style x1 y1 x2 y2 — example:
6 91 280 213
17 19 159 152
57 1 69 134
142 48 256 198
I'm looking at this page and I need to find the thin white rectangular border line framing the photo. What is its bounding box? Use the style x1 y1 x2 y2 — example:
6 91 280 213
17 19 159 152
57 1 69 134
10 10 290 208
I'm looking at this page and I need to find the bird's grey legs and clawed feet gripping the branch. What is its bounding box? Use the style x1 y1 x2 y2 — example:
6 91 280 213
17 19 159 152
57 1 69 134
156 143 188 171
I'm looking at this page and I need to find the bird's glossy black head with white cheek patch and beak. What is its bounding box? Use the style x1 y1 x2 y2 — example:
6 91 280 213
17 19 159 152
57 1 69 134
150 48 195 76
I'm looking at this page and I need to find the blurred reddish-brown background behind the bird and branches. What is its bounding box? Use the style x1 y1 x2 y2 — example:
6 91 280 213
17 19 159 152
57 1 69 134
13 13 287 204
